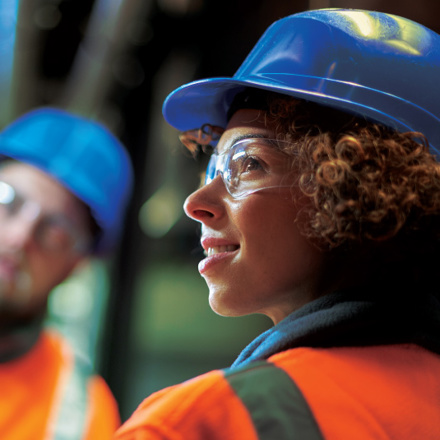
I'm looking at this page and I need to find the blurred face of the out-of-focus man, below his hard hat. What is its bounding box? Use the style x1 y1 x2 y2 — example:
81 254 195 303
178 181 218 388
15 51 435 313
0 162 89 314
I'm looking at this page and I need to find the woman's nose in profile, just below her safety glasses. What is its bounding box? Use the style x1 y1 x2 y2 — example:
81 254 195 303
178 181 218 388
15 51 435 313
183 175 226 223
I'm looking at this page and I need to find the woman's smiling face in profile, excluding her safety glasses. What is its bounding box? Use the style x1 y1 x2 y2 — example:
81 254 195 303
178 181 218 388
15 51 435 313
185 109 324 323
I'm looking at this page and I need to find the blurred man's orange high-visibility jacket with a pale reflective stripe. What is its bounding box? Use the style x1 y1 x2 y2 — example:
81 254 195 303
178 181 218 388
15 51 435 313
0 331 120 440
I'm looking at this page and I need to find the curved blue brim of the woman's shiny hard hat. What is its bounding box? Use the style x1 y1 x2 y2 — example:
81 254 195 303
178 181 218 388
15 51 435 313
163 74 440 156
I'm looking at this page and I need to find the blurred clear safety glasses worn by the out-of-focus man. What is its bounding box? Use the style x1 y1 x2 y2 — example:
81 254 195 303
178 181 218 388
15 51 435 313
0 181 91 252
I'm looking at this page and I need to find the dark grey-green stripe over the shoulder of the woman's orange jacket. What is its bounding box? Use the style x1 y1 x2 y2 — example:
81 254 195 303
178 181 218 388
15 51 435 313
225 362 324 440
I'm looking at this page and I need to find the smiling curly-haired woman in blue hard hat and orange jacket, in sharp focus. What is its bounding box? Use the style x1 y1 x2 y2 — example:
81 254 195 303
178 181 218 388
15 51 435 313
118 10 440 439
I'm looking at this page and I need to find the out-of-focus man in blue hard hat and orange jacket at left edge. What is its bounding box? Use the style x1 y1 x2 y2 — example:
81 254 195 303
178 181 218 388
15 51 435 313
0 108 133 440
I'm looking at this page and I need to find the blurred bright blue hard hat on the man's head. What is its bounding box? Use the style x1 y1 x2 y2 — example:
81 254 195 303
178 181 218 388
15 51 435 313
0 107 133 254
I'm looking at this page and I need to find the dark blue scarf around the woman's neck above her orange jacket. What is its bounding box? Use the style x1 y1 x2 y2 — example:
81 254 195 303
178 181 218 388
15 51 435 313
232 289 440 367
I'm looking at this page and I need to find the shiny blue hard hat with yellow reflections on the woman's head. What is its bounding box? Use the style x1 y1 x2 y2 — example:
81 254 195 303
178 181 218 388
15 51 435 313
163 9 440 156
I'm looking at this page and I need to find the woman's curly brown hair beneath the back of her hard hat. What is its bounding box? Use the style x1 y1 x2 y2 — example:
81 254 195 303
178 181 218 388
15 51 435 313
258 94 440 260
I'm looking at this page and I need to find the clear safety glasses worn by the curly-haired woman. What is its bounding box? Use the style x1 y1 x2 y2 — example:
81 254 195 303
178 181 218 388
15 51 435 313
205 138 293 199
